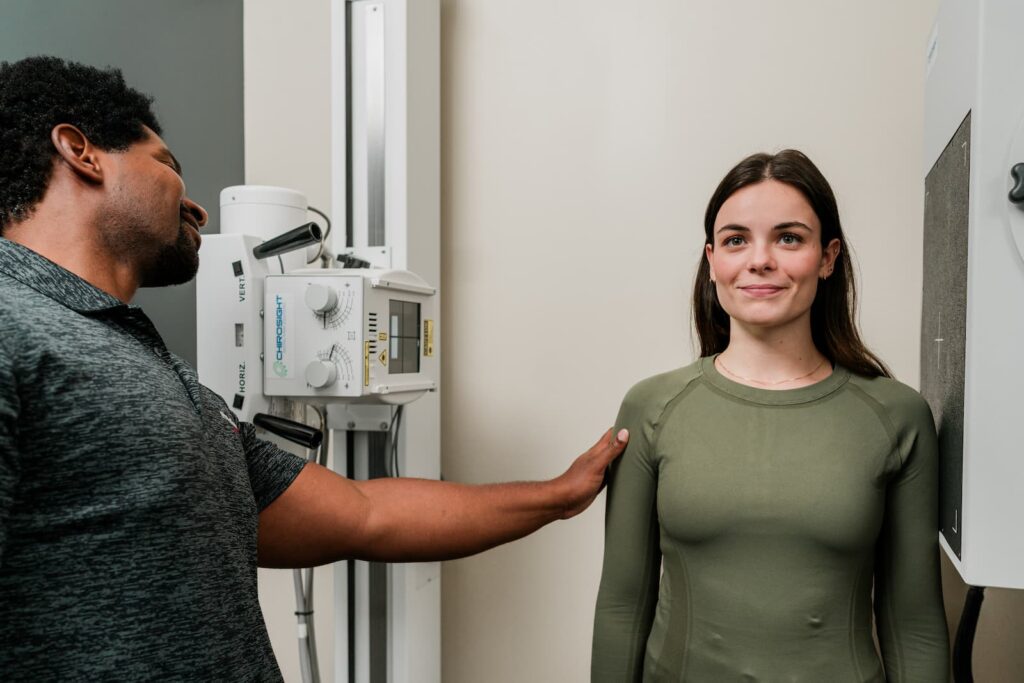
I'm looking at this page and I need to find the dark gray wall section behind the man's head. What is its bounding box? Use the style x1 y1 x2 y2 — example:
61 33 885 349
0 0 245 366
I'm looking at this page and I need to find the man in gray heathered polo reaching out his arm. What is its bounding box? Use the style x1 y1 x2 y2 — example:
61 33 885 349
0 57 627 680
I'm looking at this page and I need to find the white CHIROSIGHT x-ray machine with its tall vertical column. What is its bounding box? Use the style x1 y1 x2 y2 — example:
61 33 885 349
197 0 440 683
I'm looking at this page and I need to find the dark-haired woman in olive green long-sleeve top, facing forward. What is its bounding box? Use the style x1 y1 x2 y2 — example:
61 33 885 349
592 150 948 683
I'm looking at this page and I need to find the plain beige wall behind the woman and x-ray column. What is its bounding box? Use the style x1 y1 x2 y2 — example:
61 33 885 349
246 0 1024 683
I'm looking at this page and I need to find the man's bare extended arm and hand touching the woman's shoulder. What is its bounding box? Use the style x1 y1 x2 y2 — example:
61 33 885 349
259 430 628 567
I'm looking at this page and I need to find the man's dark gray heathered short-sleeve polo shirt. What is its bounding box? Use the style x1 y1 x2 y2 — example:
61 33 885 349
0 239 303 681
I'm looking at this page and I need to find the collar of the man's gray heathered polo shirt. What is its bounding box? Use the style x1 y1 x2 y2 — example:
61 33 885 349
0 238 126 313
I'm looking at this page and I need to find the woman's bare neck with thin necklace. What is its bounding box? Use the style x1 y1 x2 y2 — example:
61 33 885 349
717 317 833 389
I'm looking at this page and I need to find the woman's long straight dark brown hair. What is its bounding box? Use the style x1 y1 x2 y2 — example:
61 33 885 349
693 150 892 377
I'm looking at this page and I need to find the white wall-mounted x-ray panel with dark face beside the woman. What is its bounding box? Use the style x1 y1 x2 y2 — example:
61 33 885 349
921 0 1024 588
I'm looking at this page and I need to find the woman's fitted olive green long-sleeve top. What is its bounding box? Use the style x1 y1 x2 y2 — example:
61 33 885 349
592 357 949 683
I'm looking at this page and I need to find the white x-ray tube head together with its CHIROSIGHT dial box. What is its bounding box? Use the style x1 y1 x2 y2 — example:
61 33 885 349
196 185 438 424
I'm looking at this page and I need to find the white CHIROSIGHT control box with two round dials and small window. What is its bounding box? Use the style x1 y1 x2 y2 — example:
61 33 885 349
263 269 437 403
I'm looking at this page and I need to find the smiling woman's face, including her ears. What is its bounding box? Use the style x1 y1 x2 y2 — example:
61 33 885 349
705 180 840 328
